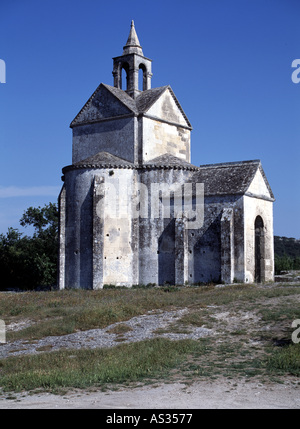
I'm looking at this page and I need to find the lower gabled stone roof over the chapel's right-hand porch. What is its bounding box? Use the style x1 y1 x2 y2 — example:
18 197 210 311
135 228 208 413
193 160 274 200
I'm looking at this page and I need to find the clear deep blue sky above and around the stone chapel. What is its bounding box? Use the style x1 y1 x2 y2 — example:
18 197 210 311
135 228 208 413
0 0 300 238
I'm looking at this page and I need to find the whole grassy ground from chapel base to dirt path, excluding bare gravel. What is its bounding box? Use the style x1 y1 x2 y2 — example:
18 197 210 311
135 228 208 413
0 284 300 391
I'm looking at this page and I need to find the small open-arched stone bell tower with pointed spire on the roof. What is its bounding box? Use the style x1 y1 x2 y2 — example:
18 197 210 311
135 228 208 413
113 21 152 99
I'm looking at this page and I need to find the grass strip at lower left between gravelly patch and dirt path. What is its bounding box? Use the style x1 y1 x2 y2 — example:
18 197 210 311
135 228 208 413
0 338 203 392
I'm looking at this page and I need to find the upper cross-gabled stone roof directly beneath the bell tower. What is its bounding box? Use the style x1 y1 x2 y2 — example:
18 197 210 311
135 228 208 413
70 83 192 128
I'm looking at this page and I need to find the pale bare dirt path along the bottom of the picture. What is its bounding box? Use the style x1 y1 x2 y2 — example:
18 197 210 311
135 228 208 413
0 380 300 409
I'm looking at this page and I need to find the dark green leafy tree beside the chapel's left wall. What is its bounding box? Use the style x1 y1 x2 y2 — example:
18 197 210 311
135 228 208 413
0 203 58 290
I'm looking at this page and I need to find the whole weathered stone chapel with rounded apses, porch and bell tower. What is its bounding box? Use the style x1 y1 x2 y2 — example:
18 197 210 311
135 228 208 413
58 21 274 289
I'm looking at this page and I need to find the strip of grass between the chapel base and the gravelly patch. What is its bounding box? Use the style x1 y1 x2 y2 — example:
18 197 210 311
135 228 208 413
0 285 295 340
